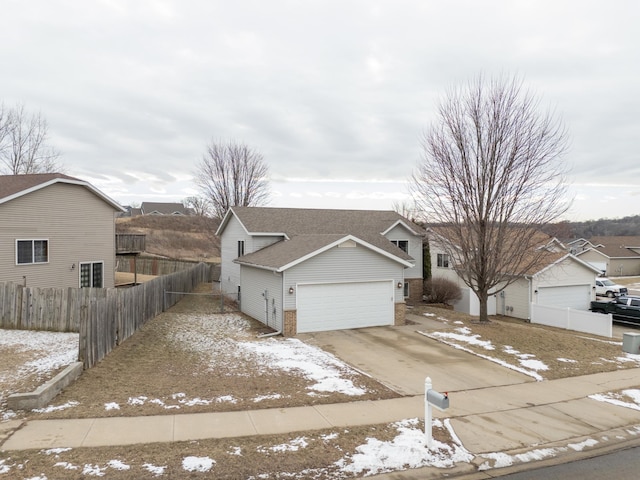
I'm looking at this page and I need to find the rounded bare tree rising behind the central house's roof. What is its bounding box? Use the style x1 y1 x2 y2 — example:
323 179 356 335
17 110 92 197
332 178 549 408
194 141 269 218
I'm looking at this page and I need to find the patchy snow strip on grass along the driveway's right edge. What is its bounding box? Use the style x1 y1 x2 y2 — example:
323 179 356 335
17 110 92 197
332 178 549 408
418 327 549 382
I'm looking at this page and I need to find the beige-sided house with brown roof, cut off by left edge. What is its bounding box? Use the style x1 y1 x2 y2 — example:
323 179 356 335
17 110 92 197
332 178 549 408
0 173 123 288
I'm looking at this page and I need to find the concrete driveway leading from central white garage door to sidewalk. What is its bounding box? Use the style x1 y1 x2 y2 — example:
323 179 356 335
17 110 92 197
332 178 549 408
298 315 534 395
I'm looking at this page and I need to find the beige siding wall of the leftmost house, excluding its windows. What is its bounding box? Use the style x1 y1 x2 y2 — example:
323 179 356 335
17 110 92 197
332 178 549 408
0 183 115 288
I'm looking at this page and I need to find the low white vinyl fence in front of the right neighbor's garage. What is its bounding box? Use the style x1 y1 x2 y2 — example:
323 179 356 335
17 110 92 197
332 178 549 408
531 303 613 337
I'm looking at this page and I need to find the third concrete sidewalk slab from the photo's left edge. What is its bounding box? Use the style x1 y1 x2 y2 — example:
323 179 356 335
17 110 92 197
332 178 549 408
173 412 258 442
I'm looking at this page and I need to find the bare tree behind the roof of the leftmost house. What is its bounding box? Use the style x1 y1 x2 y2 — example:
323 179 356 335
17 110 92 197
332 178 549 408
0 105 63 175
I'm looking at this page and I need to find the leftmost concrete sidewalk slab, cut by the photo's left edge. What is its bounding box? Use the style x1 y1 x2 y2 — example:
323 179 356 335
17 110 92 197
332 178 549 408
2 418 94 450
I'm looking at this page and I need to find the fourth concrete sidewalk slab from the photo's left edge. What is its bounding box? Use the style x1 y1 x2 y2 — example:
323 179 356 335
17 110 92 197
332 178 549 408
247 407 331 435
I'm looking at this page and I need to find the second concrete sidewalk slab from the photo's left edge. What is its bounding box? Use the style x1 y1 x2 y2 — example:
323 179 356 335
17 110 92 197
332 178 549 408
82 415 173 447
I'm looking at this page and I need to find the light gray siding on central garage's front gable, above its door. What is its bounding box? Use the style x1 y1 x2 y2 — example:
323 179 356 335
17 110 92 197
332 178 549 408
283 245 404 310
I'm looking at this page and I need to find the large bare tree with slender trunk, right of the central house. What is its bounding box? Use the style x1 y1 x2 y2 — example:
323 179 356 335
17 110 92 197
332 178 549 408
410 77 569 322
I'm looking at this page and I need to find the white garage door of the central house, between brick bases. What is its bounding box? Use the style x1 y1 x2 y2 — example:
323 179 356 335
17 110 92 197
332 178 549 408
297 281 394 333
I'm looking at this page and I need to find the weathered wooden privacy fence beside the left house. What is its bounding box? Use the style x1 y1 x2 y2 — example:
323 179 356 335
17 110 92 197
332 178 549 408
0 263 211 368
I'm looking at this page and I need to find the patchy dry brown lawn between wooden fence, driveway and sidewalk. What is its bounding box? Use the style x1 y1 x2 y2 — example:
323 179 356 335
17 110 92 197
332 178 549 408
36 284 398 418
